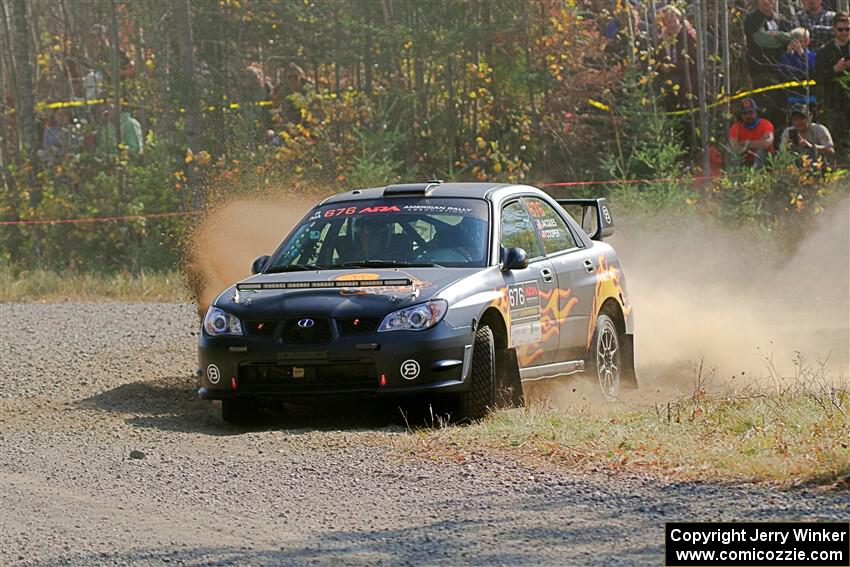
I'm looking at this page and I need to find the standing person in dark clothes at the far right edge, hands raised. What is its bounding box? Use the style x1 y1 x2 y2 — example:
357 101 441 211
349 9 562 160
815 12 850 158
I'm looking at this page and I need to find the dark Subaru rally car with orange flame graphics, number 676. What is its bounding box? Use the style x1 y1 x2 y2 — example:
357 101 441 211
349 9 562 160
199 181 637 423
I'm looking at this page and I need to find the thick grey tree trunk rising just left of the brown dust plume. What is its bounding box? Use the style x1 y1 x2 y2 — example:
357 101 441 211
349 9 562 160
175 0 206 209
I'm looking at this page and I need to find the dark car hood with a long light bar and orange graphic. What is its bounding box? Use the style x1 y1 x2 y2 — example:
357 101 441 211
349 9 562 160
215 268 482 318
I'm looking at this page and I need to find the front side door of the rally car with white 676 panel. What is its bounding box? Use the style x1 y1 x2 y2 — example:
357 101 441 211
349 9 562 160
500 199 560 368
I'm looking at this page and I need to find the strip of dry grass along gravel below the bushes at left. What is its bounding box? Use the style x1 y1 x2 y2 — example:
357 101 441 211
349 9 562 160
0 267 190 303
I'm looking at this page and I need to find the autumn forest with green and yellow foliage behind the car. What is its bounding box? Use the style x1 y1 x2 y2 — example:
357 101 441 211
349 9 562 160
0 0 848 273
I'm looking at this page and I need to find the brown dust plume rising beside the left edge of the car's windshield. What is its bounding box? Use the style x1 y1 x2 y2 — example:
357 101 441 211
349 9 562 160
186 188 329 313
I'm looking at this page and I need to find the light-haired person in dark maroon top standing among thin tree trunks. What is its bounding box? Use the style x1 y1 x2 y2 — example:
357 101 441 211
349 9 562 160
658 6 697 110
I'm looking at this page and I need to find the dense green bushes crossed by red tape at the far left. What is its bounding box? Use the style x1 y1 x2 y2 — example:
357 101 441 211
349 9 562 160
0 136 188 272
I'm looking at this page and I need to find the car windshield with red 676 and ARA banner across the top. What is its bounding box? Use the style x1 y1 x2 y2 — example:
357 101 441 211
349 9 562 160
264 197 489 273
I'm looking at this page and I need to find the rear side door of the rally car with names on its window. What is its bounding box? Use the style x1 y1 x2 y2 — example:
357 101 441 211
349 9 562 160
523 197 596 361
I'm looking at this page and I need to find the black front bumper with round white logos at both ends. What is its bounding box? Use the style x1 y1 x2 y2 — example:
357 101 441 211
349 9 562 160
198 322 474 400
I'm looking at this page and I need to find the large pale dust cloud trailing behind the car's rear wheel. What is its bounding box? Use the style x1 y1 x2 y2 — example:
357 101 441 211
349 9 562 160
611 198 850 391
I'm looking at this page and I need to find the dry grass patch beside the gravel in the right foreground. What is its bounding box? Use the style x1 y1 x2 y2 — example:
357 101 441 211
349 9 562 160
400 365 850 488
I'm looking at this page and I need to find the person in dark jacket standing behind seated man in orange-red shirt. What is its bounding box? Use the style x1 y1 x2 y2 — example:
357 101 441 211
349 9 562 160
744 0 793 130
